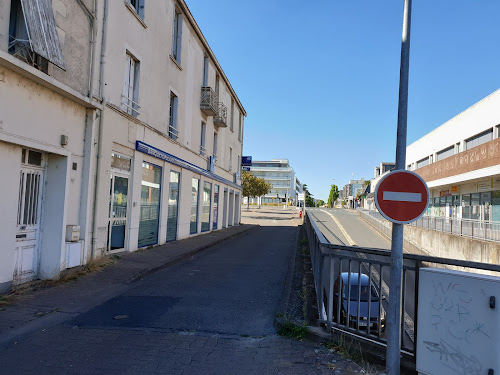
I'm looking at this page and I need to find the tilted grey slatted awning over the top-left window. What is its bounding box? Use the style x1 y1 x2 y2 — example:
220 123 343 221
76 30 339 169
21 0 65 69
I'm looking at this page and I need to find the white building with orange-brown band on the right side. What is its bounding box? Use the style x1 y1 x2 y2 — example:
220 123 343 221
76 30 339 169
406 90 500 221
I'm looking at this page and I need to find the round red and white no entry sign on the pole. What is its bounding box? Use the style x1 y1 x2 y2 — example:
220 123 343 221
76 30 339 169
375 170 429 224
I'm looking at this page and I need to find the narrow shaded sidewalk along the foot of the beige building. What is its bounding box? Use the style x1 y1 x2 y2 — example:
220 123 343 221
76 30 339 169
0 224 258 345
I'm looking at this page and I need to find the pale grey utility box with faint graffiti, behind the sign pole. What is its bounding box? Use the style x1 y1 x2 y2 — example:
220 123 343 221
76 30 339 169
417 268 500 375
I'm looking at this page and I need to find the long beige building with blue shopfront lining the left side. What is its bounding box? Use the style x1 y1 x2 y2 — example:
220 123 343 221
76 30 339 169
0 0 246 291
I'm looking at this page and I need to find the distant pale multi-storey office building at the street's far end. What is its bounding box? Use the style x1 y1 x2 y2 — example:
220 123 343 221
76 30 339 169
250 159 303 205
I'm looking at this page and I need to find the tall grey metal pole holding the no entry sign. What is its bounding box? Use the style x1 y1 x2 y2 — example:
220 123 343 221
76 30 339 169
386 0 411 375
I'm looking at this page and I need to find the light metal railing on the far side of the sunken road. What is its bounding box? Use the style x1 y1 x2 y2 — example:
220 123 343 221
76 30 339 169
360 210 500 242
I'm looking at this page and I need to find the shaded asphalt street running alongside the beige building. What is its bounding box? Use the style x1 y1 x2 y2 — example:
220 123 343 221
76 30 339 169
0 210 368 375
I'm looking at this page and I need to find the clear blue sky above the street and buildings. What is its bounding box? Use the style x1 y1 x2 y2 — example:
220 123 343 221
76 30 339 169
186 0 500 201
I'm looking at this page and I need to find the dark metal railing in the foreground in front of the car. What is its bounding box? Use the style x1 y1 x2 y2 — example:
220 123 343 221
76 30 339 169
304 212 500 356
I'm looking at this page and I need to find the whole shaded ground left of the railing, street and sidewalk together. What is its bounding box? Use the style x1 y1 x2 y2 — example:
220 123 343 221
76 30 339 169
0 208 382 375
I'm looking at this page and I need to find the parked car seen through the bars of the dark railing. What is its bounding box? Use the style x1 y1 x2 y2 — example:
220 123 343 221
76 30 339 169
333 272 386 331
